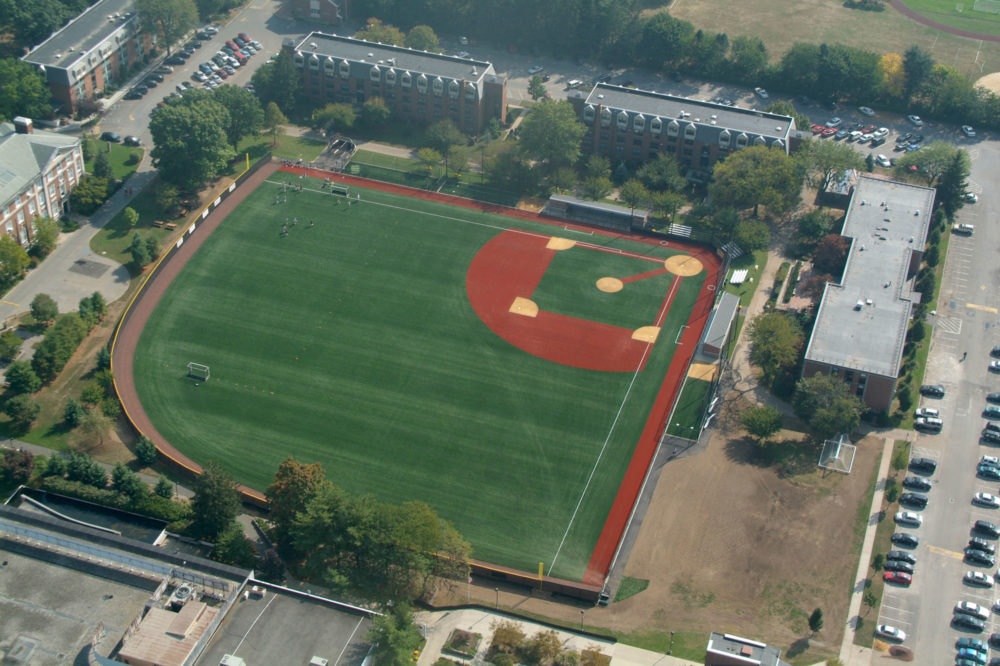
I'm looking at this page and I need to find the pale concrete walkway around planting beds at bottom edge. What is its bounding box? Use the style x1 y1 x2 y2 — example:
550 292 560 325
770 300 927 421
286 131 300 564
414 608 700 666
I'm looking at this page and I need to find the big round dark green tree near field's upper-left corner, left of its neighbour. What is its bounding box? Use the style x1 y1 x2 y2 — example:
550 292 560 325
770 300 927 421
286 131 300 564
149 90 235 188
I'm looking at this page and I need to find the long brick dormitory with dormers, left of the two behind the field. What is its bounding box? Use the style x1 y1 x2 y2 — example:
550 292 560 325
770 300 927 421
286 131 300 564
293 32 507 135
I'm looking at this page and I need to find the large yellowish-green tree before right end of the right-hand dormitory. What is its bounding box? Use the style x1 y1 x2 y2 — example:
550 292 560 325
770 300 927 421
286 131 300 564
708 146 802 217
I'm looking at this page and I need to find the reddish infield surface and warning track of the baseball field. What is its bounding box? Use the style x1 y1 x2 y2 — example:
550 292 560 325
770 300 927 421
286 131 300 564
112 165 720 586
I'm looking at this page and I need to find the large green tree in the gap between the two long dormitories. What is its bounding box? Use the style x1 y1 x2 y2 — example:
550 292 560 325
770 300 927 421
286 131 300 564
520 100 587 171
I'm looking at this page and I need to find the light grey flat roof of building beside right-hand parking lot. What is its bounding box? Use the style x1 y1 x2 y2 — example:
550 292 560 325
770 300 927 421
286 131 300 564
805 176 934 377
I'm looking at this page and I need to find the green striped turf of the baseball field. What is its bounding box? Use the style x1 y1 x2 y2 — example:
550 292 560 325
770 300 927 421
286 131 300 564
135 173 704 579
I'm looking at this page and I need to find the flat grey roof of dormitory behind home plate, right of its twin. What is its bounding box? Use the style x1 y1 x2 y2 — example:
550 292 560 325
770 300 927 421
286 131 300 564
578 83 794 142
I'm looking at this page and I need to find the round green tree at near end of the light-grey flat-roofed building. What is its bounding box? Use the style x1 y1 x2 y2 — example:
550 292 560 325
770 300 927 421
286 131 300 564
792 374 864 441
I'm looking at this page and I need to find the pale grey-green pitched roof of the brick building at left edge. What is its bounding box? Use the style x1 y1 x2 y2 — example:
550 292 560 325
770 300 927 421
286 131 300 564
0 123 80 207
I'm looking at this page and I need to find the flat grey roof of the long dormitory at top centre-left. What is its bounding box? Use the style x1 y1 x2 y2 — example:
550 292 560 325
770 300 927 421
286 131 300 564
295 32 496 82
